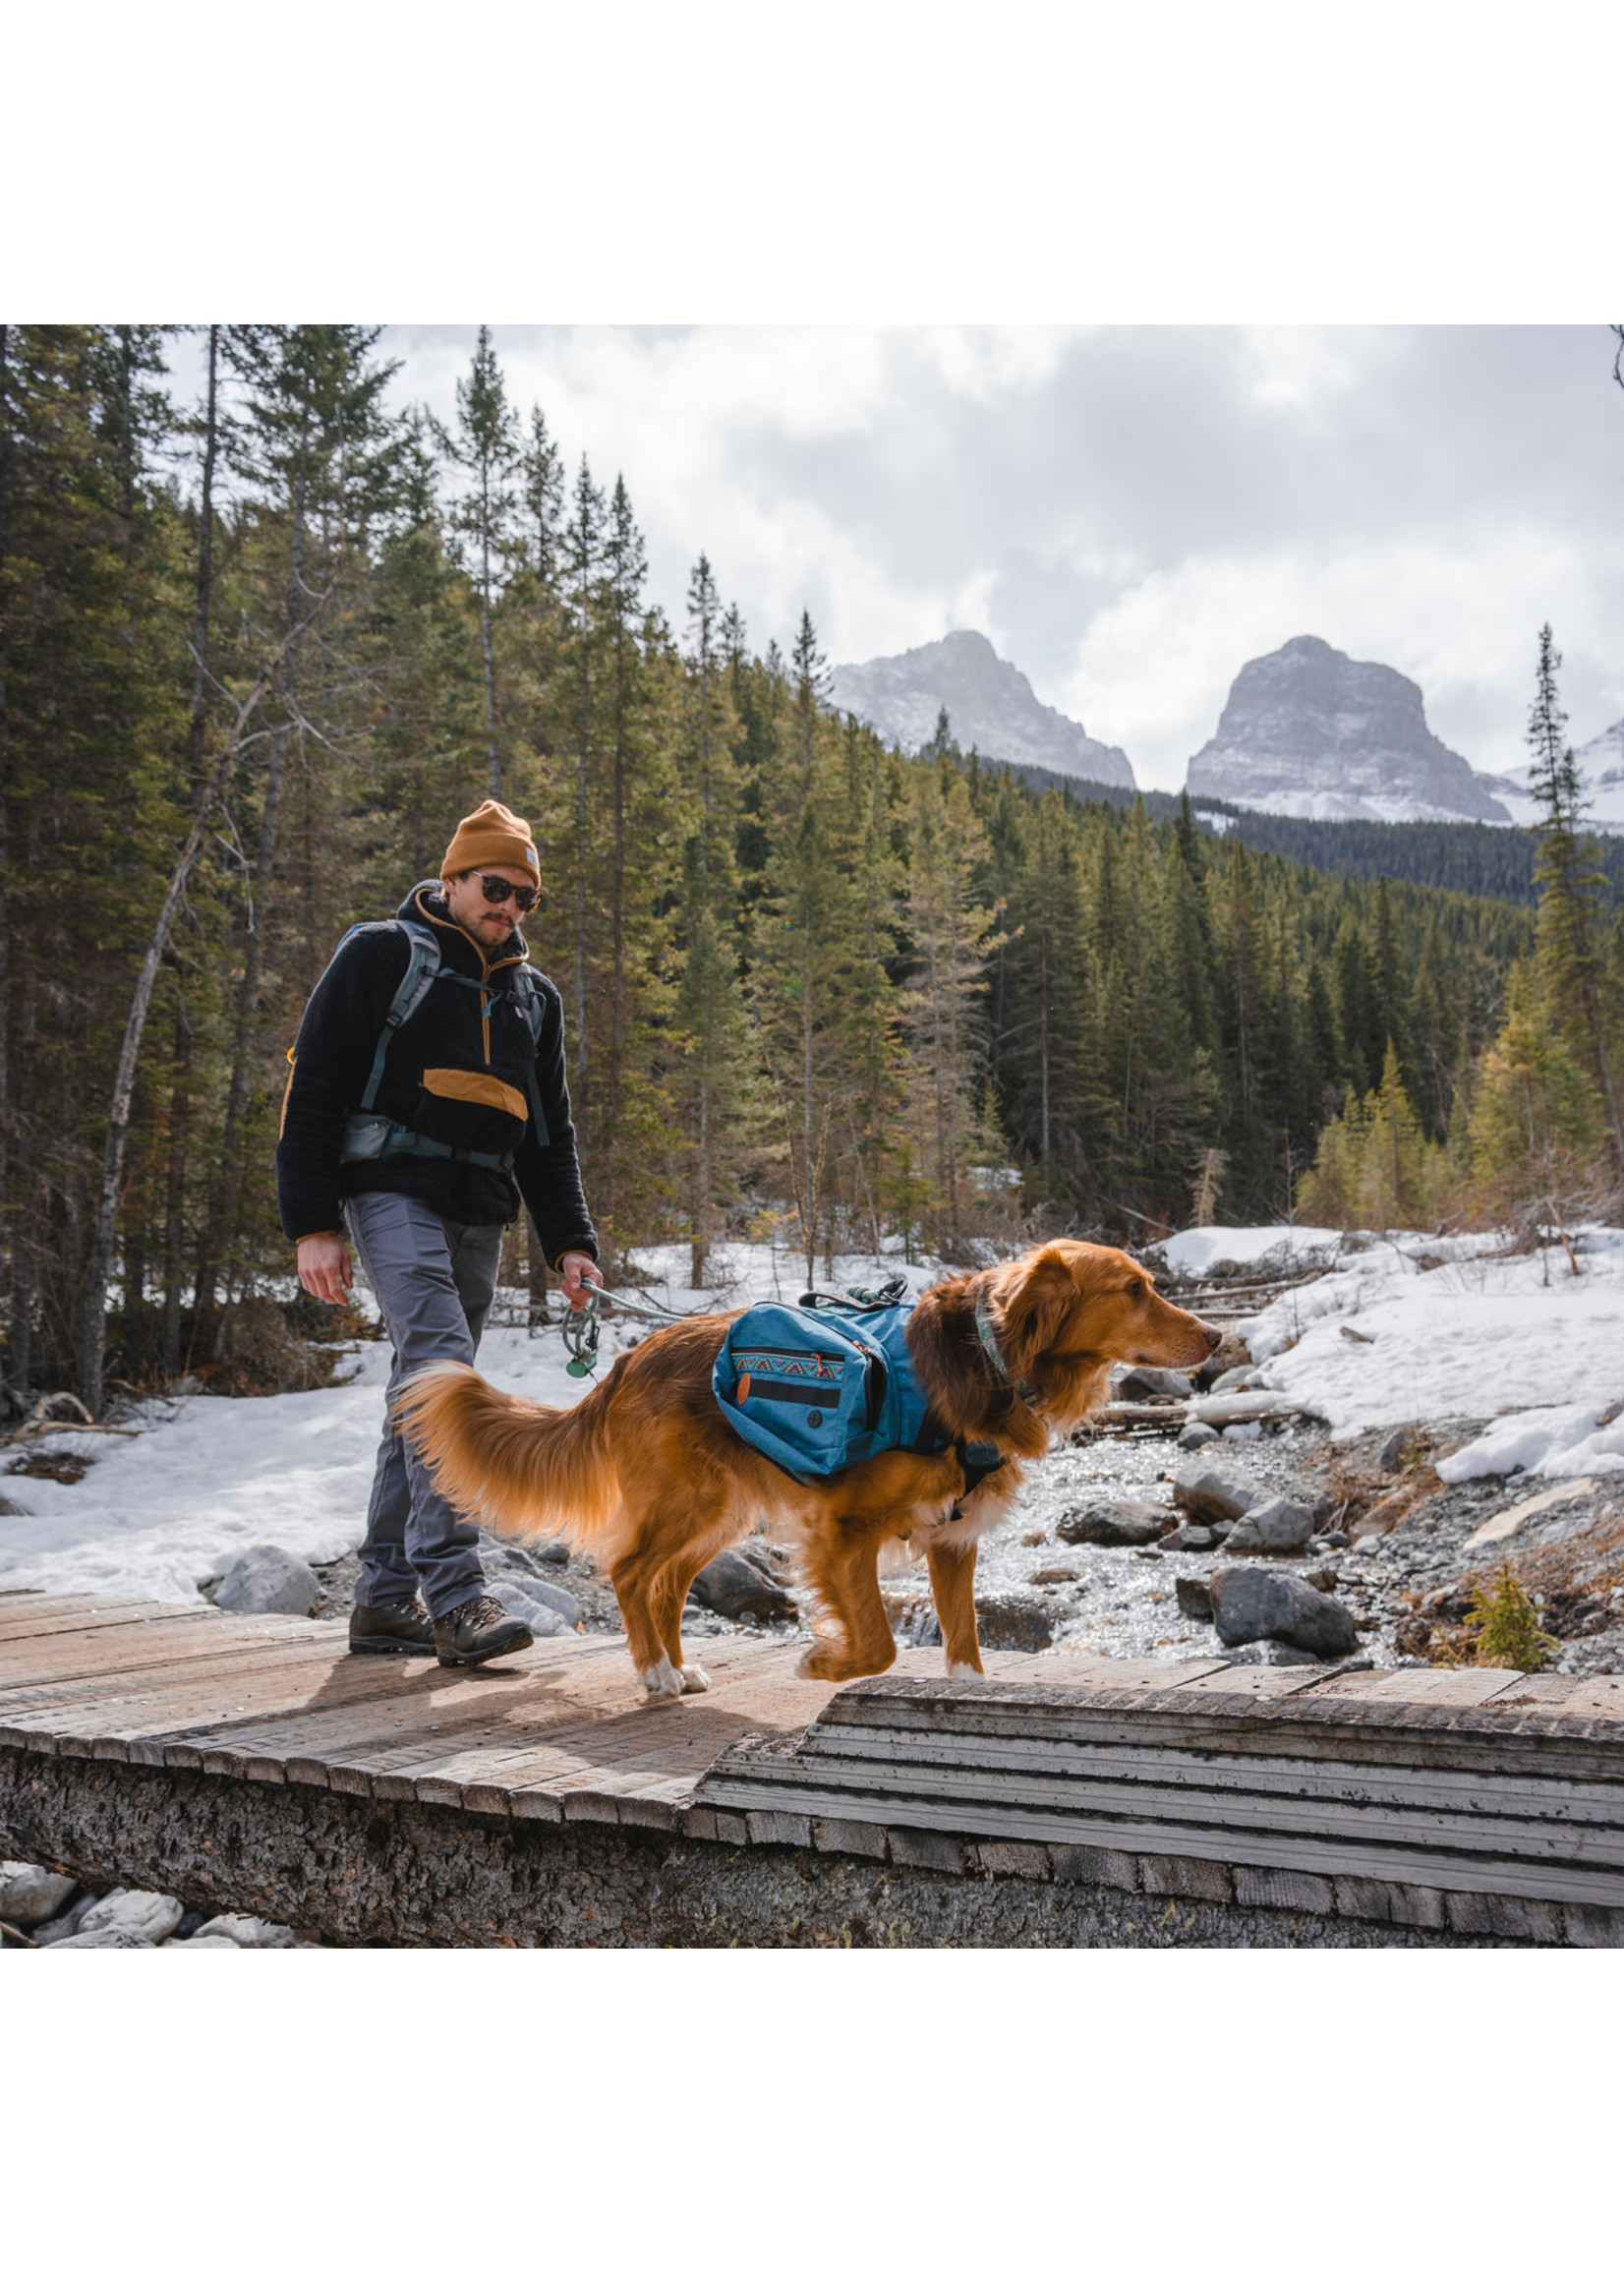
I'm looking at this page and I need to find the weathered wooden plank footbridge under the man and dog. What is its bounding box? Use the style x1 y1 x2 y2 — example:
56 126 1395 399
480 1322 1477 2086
0 1594 1624 1942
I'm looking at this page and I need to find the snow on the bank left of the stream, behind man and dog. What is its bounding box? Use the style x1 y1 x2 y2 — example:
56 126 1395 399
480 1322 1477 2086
0 1244 940 1603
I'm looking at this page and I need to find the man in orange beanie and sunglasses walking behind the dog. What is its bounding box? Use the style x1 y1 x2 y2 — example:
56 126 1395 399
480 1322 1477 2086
275 798 603 1666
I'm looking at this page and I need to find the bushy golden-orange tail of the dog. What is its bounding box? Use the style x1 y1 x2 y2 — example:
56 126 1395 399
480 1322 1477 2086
393 1360 618 1540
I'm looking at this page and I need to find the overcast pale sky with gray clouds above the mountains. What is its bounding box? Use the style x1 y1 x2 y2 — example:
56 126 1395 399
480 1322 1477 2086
167 325 1624 789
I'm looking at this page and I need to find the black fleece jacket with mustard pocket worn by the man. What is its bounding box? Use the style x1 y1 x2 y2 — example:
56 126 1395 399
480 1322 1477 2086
275 880 599 1264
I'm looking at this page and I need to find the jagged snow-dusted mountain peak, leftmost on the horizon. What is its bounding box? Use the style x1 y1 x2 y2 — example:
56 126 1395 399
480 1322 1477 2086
828 632 1135 789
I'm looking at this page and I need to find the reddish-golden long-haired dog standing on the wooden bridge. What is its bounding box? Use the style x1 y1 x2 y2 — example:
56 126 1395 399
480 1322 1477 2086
396 1240 1221 1699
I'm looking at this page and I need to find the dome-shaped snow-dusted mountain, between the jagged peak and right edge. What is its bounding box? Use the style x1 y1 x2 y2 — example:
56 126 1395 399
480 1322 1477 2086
1185 634 1510 823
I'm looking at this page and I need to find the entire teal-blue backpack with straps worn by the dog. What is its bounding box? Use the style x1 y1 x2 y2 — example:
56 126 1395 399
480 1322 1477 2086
710 1280 1003 1491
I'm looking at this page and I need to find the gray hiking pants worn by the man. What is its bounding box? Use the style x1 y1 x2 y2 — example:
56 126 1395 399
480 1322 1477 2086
343 1192 502 1619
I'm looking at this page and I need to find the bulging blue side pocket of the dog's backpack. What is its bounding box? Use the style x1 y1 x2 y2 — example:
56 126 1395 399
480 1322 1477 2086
710 1303 887 1481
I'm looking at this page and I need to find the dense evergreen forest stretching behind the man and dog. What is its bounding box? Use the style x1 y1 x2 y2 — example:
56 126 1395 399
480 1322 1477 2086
0 325 1624 1410
